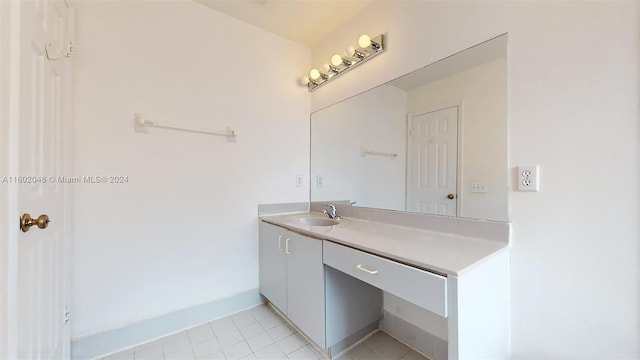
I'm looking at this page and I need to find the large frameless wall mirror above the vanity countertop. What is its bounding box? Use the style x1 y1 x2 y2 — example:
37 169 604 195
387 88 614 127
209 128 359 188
311 34 509 221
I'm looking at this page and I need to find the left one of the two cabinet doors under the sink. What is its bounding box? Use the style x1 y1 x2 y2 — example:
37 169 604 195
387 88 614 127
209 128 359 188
258 221 287 314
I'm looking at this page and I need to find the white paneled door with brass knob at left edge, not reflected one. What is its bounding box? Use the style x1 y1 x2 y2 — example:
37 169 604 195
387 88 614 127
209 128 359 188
3 0 69 359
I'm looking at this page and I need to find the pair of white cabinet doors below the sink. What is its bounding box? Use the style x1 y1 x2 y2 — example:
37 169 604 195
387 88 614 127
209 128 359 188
259 222 325 347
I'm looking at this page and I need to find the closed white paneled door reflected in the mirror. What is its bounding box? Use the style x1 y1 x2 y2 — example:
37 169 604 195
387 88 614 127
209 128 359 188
407 106 458 216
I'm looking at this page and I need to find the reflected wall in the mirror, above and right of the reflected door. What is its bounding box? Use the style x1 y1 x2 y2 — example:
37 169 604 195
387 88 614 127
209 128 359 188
407 59 508 221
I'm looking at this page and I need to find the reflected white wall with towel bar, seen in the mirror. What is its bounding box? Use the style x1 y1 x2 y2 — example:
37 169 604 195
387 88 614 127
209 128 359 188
311 85 407 210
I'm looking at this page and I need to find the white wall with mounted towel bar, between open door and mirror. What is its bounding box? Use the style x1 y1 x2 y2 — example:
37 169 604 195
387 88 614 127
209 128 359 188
72 1 310 337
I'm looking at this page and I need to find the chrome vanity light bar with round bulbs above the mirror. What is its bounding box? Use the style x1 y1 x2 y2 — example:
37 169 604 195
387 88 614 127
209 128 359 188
300 34 385 91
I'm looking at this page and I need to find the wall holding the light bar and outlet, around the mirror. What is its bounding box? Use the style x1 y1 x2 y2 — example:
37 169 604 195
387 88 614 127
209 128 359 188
312 2 640 358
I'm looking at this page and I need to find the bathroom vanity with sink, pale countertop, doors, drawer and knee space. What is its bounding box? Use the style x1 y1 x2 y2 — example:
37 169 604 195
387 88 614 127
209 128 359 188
260 206 509 359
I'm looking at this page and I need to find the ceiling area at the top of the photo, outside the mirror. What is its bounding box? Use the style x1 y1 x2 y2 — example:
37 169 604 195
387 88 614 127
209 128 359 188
195 0 371 46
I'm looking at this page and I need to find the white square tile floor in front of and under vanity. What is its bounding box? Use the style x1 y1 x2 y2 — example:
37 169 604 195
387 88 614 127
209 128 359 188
103 305 427 360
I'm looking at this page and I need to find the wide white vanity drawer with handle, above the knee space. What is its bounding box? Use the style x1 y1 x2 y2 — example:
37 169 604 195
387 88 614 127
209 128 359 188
322 240 447 317
